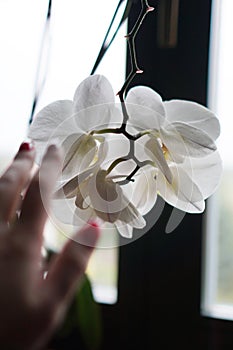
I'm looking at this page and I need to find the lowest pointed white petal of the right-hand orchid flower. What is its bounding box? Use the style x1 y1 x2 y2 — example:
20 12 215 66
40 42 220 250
157 164 205 213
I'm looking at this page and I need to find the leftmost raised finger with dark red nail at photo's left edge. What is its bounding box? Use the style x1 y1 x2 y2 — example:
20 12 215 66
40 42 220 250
0 142 35 223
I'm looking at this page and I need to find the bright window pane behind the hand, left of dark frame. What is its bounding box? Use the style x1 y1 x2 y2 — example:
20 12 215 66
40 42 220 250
0 0 126 303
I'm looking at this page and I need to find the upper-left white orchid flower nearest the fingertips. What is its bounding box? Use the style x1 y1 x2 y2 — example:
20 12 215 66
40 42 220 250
28 75 119 180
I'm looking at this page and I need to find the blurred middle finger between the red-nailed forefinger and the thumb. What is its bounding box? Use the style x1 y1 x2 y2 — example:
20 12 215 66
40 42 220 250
15 145 61 249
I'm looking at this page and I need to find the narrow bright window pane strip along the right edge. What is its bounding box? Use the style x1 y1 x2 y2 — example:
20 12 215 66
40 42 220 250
202 0 233 320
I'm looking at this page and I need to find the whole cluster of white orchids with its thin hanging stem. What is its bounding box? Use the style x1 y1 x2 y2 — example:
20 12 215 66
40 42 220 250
29 2 222 238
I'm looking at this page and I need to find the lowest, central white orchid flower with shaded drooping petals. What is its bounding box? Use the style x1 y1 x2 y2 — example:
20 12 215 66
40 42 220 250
54 144 157 238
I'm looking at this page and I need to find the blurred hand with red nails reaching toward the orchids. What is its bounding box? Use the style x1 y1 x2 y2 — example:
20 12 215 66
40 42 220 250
0 143 99 350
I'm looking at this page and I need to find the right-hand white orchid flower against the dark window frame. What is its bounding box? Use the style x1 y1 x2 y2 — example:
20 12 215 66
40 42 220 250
126 86 222 213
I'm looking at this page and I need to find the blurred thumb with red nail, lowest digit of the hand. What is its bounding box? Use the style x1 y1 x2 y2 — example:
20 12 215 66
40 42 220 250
47 224 100 306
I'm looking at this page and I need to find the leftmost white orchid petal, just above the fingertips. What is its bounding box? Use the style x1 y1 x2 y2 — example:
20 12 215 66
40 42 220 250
28 100 74 163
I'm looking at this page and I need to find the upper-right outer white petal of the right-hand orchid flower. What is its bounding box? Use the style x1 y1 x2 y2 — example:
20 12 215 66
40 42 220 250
164 100 220 140
